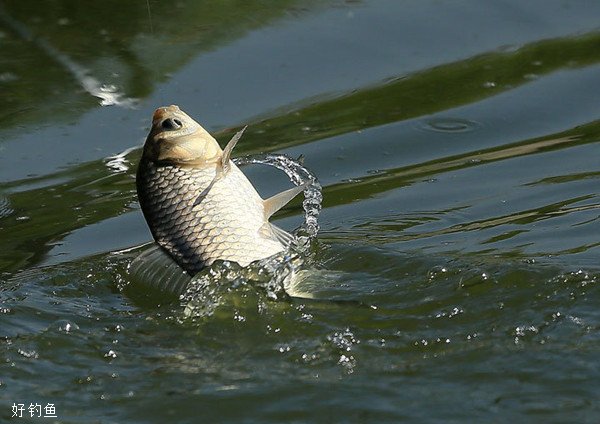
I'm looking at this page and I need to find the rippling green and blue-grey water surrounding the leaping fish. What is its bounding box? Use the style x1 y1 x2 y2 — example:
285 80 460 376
0 0 600 423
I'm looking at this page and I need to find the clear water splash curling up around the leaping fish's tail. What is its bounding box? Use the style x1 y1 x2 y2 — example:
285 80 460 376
119 154 323 318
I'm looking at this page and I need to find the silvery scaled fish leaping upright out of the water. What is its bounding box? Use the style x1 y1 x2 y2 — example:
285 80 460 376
136 105 307 276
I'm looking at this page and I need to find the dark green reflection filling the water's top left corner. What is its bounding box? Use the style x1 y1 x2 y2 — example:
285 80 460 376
0 0 320 130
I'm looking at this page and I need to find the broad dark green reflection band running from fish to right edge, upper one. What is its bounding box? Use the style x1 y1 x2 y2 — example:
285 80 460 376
237 32 600 149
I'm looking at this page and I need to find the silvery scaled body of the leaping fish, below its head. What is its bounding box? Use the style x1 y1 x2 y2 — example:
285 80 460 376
138 156 284 274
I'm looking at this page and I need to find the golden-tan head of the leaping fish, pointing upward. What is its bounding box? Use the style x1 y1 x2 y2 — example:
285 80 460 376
143 105 223 165
